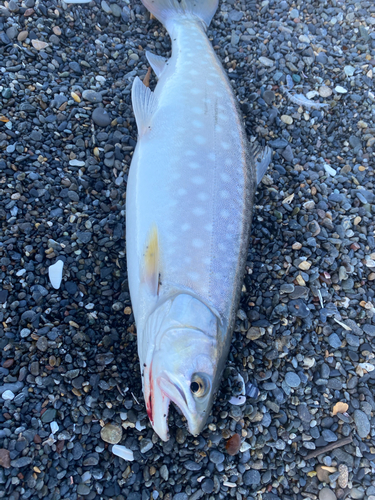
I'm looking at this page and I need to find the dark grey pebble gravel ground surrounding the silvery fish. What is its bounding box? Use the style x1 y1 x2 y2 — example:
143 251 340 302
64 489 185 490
0 0 375 500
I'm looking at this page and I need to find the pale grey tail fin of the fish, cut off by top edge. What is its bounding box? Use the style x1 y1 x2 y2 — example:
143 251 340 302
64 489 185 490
142 0 219 28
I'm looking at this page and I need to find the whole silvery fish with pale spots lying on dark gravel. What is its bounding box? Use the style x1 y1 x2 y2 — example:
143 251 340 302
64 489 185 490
126 0 272 441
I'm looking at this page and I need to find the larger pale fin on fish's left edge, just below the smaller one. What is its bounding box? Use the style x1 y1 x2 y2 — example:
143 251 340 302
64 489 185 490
132 76 157 136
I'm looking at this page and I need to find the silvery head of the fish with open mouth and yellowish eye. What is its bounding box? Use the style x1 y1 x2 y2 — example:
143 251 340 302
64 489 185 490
143 294 221 441
